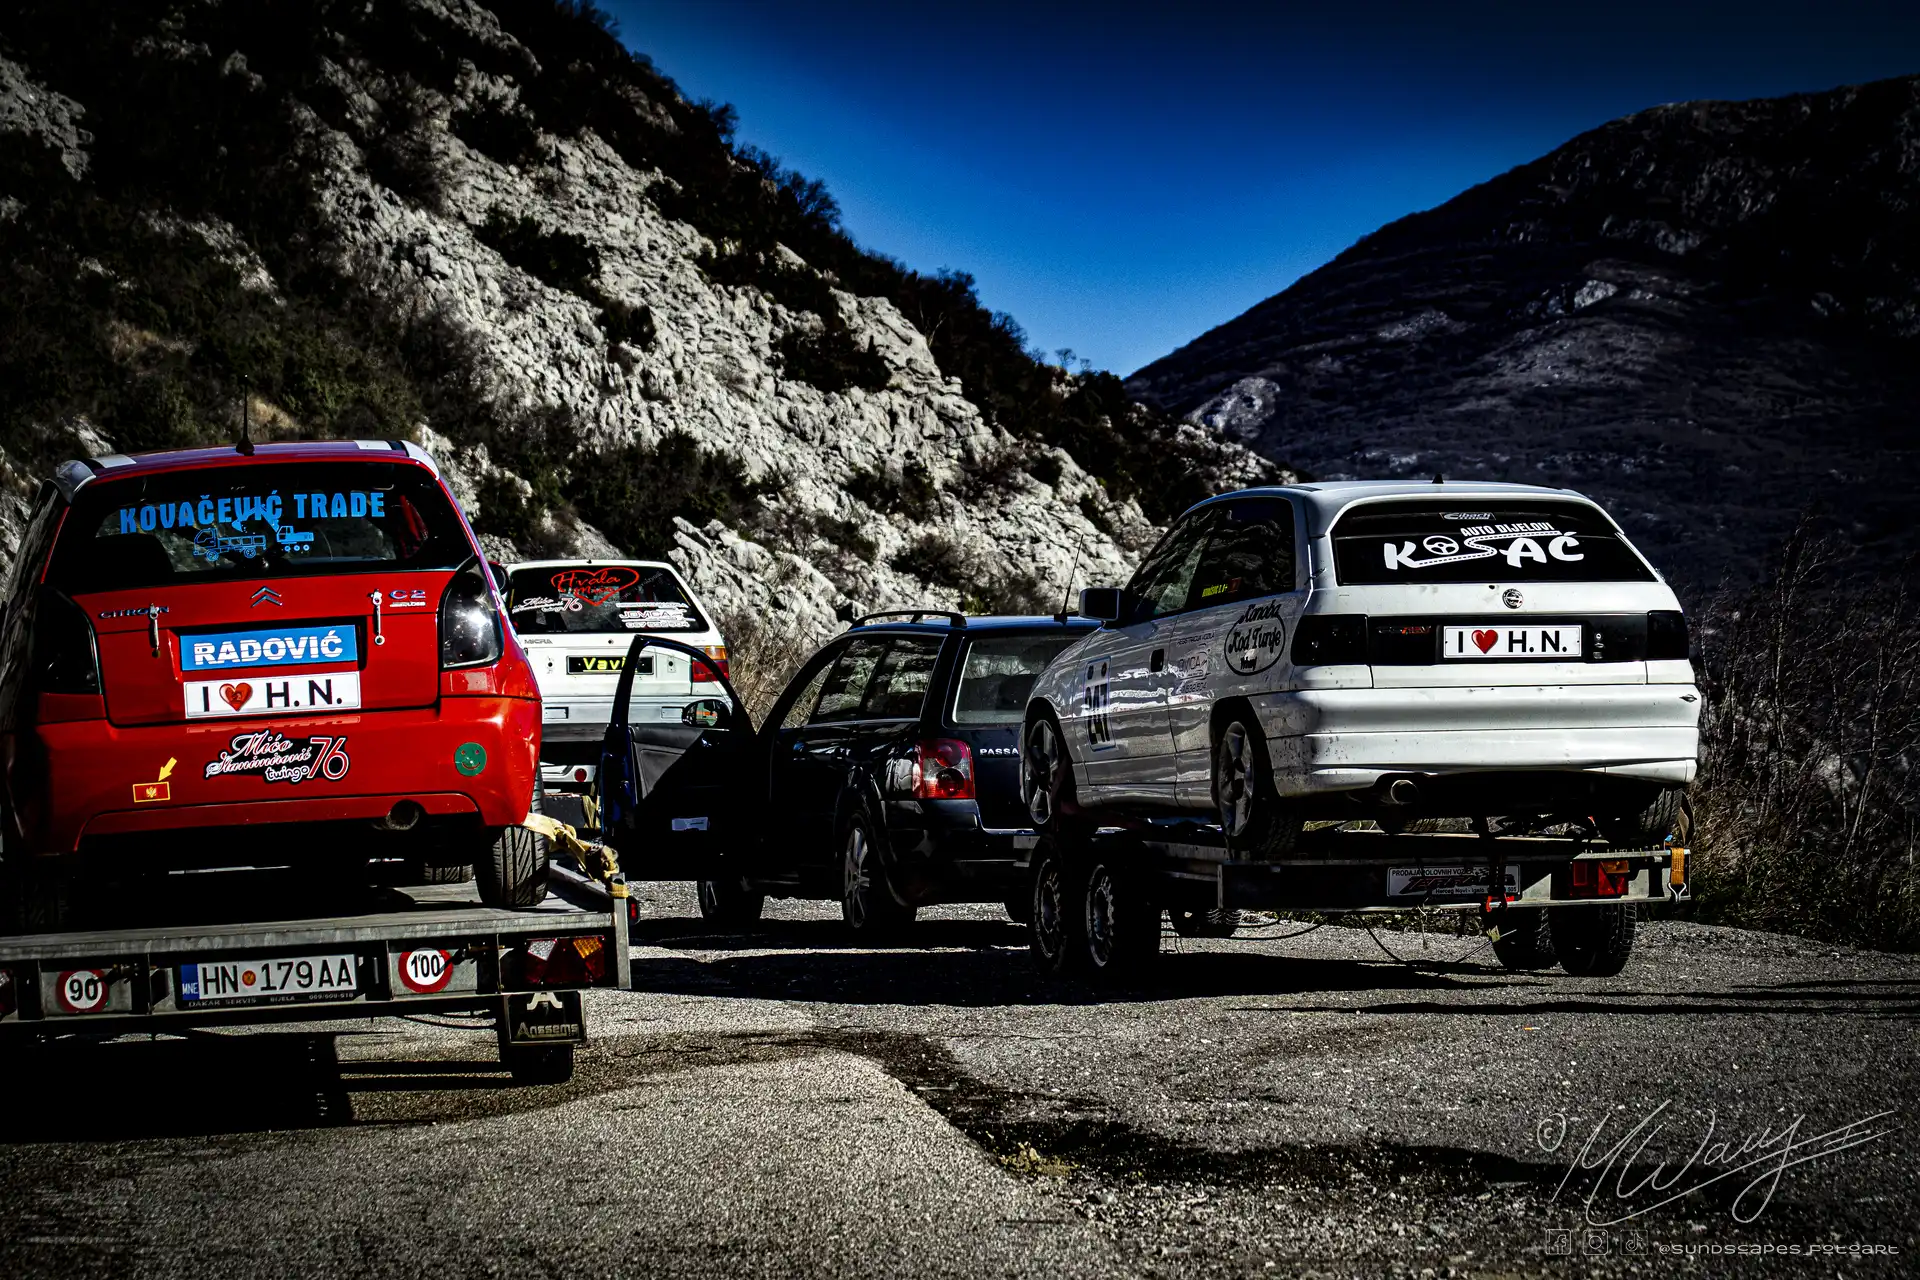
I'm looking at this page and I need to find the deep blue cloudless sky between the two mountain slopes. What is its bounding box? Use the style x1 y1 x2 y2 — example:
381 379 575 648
601 0 1920 372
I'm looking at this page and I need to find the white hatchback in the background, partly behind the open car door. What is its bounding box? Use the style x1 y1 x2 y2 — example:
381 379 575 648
503 560 728 789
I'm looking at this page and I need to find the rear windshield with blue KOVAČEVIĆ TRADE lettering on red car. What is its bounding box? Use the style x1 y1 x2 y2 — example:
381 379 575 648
48 462 474 595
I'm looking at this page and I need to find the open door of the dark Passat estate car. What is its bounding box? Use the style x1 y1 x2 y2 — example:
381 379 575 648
593 635 760 881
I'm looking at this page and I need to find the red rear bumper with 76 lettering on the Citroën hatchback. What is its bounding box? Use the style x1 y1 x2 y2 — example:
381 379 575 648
8 697 540 854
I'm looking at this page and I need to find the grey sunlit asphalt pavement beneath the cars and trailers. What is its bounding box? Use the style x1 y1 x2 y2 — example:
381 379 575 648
0 885 1920 1278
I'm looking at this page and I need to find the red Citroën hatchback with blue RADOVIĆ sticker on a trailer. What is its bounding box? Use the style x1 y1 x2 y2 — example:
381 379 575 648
0 439 547 917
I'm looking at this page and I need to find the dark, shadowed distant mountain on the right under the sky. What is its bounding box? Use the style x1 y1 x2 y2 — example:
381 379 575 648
1127 77 1920 583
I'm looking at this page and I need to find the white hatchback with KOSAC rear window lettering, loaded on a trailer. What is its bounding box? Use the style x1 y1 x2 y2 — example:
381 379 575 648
1021 482 1699 858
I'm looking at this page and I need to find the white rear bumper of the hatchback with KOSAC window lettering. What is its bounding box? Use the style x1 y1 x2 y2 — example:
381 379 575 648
1260 685 1699 796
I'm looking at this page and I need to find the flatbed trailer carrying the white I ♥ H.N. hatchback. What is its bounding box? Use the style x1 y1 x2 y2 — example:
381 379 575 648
1027 819 1692 979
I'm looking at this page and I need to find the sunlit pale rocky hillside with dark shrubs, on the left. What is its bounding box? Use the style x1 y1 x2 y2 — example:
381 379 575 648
0 0 1273 702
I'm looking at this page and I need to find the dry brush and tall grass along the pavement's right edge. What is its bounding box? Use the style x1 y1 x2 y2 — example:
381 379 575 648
1693 522 1920 950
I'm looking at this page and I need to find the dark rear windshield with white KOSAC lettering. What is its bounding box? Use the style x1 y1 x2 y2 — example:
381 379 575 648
1332 499 1653 585
